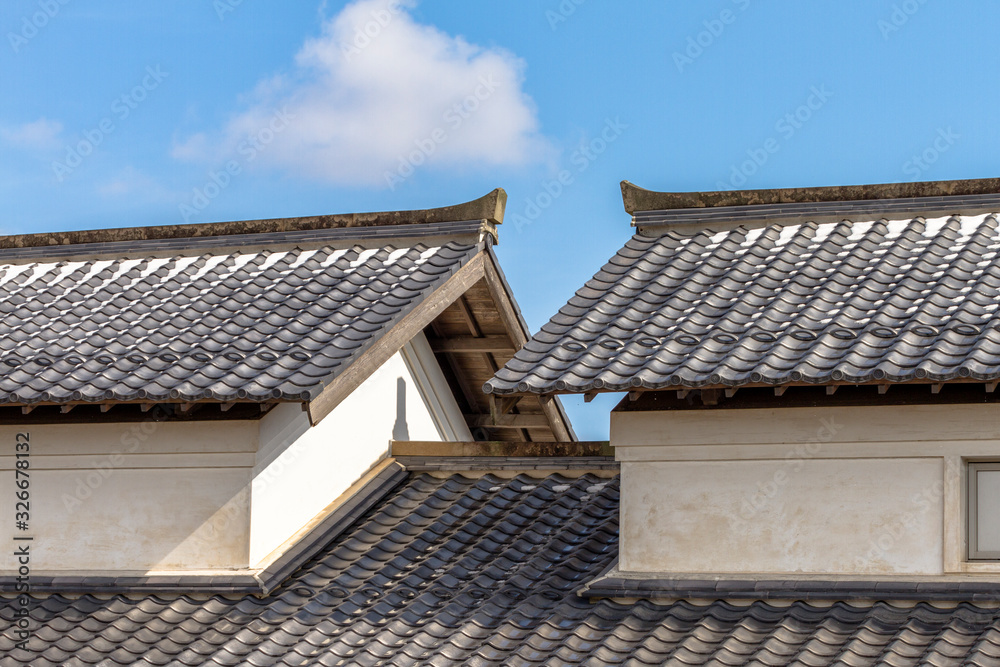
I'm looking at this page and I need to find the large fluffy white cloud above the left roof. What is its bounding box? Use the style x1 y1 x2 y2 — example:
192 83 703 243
173 0 549 185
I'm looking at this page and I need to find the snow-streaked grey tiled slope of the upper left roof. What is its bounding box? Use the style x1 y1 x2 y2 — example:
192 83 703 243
0 235 480 404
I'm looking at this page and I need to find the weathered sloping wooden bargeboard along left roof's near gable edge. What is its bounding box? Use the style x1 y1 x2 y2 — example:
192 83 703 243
307 251 486 426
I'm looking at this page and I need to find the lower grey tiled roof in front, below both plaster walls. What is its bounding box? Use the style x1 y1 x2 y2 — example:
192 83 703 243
0 474 1000 667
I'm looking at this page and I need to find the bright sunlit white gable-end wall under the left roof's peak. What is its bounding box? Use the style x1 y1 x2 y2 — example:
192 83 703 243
250 334 460 565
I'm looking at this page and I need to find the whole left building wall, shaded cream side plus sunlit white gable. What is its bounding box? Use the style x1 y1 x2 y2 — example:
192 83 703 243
0 335 464 575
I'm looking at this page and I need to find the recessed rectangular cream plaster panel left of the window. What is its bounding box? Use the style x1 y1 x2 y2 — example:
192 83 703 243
620 459 943 575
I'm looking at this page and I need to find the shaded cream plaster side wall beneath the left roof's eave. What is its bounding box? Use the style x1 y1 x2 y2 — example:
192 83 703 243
0 421 257 573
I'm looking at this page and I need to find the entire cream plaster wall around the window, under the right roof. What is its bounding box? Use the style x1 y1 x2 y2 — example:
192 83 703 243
611 405 1000 577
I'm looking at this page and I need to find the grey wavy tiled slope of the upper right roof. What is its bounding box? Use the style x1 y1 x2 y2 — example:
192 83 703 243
484 214 1000 394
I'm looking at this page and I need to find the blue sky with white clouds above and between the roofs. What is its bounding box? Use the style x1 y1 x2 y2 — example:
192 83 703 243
0 0 1000 439
